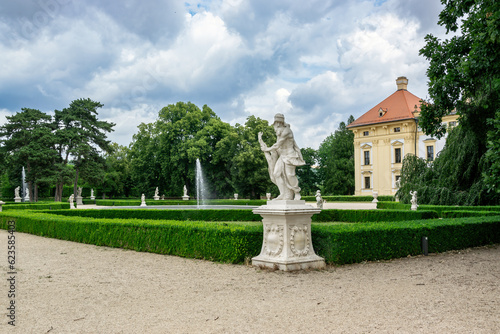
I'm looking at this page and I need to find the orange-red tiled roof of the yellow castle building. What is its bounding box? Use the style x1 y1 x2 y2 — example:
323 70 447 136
347 89 421 128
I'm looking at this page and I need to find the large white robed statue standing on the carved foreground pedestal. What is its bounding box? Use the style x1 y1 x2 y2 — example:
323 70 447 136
258 114 305 200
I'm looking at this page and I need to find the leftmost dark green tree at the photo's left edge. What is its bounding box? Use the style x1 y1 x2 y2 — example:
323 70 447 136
0 108 56 201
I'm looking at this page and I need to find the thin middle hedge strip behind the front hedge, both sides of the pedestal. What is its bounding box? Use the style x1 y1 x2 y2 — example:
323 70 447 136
47 209 438 223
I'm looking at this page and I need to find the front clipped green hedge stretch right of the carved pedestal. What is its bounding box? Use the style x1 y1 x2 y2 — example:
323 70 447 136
311 216 500 264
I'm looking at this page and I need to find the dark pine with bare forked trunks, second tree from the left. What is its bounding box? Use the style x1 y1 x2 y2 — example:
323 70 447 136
54 99 115 201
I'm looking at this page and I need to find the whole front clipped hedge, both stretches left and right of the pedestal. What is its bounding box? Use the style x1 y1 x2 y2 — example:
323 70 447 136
0 211 500 264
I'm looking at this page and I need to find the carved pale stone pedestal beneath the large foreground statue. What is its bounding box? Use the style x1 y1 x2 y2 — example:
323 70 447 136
252 200 325 271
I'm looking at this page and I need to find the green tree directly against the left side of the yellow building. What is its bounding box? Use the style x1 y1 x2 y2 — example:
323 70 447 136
318 115 354 195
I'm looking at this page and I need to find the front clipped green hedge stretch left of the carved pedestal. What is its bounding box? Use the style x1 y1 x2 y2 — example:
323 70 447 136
0 211 262 263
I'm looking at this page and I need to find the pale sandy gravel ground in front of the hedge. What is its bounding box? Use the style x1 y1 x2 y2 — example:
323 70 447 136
0 230 500 334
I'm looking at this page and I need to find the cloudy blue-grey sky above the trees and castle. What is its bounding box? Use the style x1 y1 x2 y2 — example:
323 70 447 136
0 0 444 148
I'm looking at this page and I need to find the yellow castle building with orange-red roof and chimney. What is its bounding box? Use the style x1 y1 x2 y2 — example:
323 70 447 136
347 77 458 195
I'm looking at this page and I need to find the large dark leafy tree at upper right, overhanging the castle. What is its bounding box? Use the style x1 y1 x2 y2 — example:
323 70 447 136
419 0 500 192
